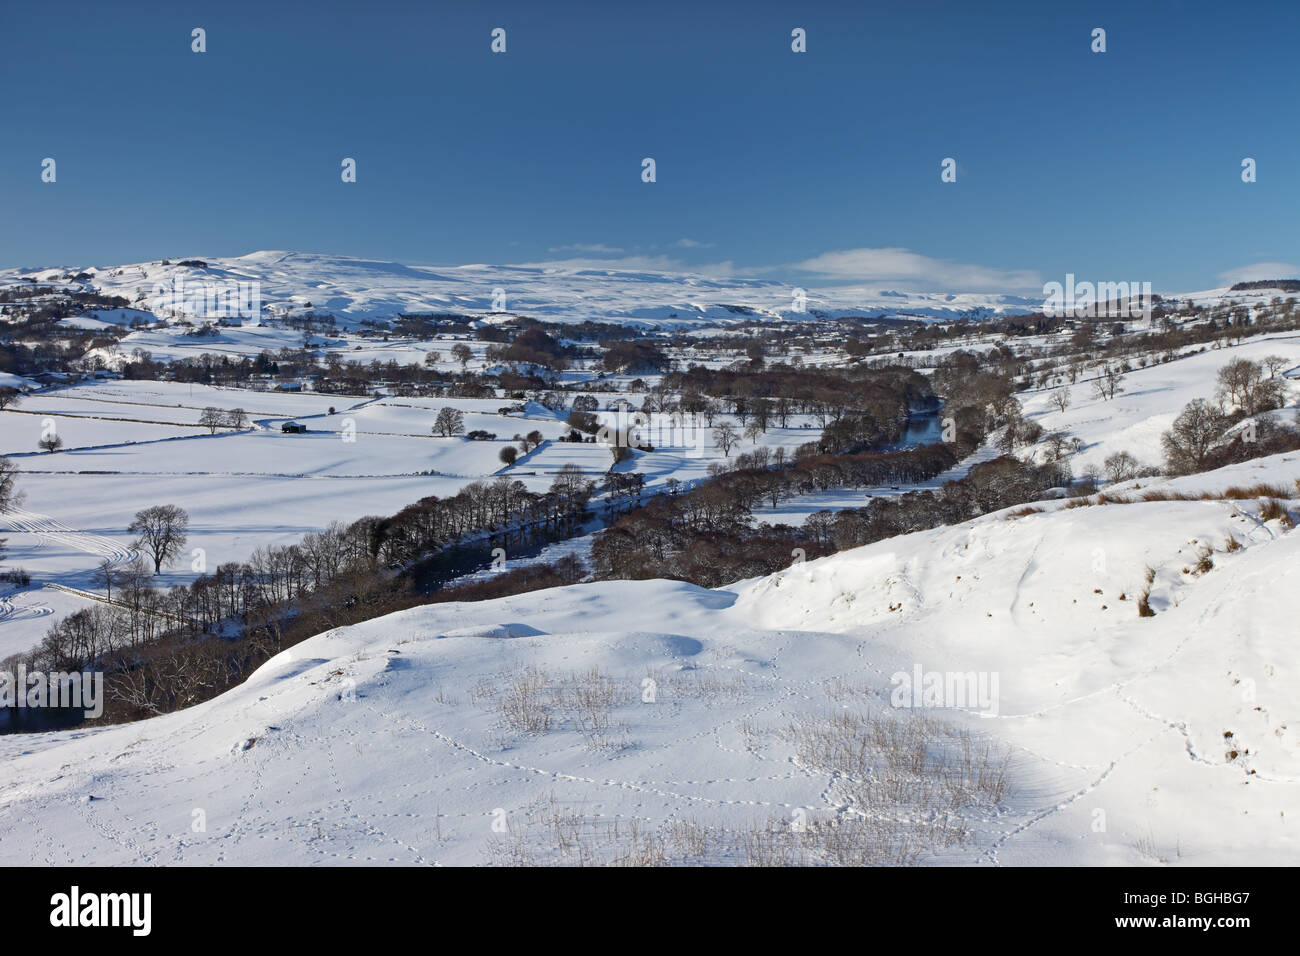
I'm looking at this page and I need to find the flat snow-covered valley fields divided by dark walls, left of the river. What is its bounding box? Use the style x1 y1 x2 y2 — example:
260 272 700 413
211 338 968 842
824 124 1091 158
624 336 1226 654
0 380 816 658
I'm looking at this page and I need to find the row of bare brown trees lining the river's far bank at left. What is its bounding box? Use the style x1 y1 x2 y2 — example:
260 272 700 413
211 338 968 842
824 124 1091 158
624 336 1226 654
10 459 593 713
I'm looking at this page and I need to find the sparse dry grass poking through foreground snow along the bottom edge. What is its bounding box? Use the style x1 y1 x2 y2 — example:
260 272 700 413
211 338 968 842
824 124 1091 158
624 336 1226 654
486 702 1009 866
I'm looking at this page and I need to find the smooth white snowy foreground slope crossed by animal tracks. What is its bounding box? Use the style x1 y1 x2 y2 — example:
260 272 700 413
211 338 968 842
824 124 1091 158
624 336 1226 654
0 455 1300 865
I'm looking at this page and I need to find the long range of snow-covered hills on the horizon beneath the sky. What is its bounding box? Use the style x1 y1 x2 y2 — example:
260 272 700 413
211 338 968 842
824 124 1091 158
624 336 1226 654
0 251 1041 326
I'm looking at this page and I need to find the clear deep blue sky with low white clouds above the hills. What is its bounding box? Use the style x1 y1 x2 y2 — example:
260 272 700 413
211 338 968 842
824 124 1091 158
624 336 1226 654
0 0 1300 291
